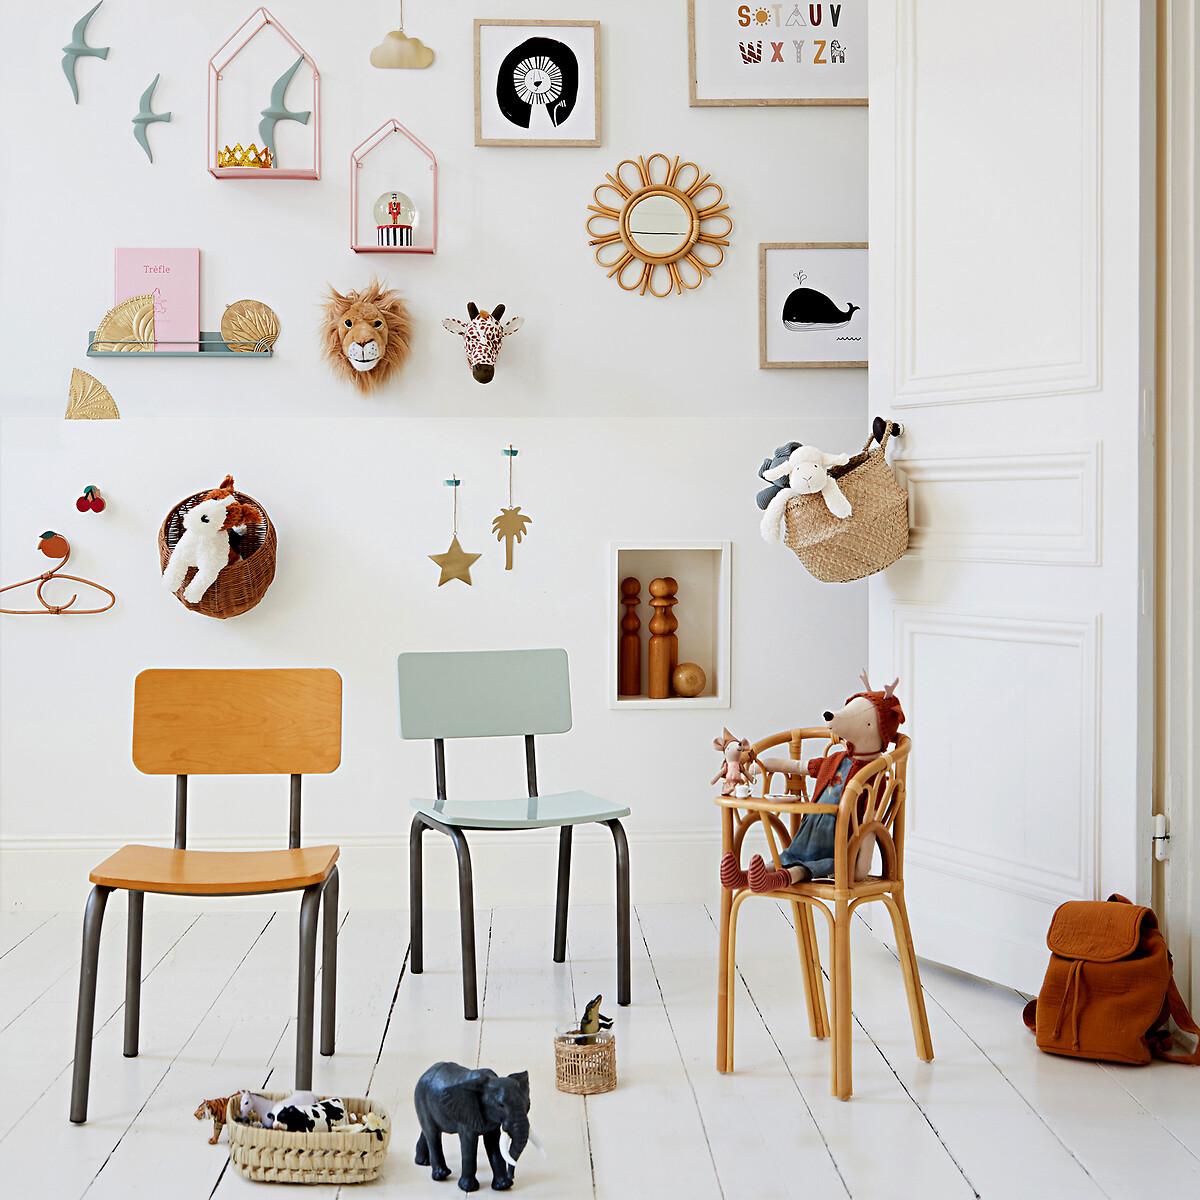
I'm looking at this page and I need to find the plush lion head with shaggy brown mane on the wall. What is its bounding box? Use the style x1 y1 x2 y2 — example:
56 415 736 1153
323 280 413 392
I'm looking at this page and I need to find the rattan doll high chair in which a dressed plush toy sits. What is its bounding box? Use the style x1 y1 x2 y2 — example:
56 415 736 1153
716 727 934 1100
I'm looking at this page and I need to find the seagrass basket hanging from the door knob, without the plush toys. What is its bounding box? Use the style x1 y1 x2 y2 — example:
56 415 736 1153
784 421 908 583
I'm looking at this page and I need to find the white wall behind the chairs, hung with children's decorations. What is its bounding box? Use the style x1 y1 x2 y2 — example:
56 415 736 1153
0 0 868 907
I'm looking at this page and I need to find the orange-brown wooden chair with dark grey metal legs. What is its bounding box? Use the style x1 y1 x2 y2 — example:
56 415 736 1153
71 670 342 1123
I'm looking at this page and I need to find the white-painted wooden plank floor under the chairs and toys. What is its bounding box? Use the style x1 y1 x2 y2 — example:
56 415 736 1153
0 896 1200 1200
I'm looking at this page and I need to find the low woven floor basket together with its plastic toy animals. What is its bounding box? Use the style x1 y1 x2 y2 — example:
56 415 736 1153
224 1092 391 1183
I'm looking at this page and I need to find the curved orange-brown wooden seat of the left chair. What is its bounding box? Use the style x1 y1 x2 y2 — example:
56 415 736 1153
90 845 338 896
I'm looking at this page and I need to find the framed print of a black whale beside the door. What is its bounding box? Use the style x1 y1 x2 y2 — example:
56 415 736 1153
758 241 866 367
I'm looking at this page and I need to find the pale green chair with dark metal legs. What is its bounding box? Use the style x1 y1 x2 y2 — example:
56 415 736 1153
398 649 630 1021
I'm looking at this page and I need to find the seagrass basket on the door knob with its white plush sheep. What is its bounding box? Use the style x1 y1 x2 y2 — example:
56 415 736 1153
757 416 908 583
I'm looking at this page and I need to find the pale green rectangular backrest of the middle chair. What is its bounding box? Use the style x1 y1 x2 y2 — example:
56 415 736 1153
397 649 571 739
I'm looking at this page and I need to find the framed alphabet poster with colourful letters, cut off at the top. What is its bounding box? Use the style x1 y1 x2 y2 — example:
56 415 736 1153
688 0 866 108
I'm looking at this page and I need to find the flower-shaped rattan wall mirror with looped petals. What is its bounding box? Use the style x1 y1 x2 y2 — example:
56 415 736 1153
586 152 733 298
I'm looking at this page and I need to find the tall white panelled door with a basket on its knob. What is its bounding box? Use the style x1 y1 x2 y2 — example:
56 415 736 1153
869 0 1154 990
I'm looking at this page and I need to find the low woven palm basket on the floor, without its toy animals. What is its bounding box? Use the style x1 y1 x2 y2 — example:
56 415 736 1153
226 1092 391 1183
